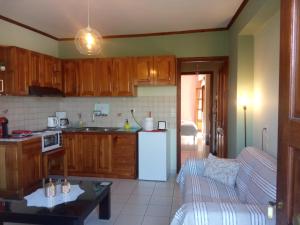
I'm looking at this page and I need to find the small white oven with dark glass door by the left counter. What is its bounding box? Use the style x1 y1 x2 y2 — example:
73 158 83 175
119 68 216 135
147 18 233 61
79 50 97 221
42 131 62 152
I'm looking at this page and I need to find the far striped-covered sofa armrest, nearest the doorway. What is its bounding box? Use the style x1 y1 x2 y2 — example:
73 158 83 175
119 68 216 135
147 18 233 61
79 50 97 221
176 159 206 186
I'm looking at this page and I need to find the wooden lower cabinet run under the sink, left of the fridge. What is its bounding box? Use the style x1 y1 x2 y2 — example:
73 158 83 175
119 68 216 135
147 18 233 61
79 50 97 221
63 133 137 178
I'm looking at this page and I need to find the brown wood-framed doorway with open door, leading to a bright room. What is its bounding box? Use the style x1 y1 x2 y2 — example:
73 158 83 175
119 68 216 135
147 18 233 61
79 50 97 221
177 57 228 171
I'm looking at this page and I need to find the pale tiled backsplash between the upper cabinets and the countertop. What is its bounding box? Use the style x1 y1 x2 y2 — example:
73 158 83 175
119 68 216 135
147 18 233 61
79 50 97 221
0 96 176 130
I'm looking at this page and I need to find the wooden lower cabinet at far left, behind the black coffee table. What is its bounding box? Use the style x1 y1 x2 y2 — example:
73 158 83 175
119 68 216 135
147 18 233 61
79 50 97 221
0 138 42 198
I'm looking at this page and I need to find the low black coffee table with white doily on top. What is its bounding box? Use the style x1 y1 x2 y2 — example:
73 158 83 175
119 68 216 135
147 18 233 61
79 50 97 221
0 181 112 225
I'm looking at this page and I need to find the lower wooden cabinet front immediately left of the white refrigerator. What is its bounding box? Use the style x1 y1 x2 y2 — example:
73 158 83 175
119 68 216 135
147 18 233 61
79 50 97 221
112 134 136 178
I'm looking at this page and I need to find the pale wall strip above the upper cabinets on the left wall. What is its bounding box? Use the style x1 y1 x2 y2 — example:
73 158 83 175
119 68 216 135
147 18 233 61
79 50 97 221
0 19 58 56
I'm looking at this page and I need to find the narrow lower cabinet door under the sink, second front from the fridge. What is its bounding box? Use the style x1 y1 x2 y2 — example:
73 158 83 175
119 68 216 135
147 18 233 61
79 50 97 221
96 135 111 173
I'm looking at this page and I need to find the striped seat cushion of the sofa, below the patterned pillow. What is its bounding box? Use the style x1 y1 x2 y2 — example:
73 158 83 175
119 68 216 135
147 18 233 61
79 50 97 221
183 176 240 203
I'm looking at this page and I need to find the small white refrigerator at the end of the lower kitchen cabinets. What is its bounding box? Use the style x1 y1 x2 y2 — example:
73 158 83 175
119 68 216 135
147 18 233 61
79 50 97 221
138 131 170 181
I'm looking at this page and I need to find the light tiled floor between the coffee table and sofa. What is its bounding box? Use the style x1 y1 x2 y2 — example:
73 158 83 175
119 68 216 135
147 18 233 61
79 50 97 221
81 177 181 225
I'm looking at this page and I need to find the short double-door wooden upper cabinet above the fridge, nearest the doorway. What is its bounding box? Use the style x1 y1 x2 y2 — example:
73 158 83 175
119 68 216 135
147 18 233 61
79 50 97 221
134 56 176 85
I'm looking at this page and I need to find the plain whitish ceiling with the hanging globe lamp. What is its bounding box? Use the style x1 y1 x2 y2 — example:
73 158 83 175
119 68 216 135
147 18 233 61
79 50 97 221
0 0 243 38
